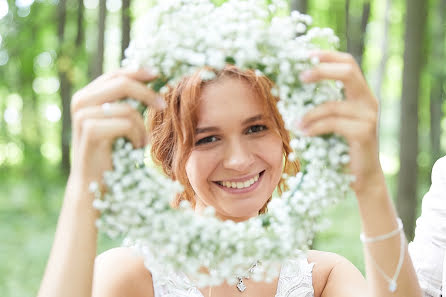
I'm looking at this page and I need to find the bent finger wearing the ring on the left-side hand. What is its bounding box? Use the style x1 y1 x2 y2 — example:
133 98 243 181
73 103 147 147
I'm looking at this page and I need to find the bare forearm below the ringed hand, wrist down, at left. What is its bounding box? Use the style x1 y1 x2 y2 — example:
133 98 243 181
38 181 97 297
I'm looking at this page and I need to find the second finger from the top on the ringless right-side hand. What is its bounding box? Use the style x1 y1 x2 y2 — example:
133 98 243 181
300 63 368 99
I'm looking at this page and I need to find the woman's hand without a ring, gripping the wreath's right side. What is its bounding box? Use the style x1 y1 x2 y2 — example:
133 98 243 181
299 51 382 194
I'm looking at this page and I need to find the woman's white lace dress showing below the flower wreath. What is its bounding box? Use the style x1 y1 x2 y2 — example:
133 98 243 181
152 258 314 297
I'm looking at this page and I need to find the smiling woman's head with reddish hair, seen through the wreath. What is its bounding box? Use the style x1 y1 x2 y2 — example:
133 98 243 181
148 66 299 217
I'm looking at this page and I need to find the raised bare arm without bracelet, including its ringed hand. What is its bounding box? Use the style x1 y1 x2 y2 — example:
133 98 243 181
38 70 160 297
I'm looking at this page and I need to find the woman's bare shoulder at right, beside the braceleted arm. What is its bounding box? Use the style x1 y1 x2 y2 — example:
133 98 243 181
308 250 366 297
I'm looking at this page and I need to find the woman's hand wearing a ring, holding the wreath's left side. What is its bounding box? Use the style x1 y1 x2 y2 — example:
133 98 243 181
70 69 165 194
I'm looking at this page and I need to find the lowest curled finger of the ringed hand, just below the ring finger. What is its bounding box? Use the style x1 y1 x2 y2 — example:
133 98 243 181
80 118 144 148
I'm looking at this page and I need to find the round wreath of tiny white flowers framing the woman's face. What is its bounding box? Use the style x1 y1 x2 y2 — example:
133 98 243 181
94 0 351 286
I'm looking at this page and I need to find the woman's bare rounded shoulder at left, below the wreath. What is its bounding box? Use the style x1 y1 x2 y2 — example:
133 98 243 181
93 248 154 297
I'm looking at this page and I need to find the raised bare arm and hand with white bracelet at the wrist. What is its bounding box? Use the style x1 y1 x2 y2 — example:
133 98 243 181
300 51 421 297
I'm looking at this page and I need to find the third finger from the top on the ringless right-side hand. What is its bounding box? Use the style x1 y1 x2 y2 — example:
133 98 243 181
299 101 377 129
